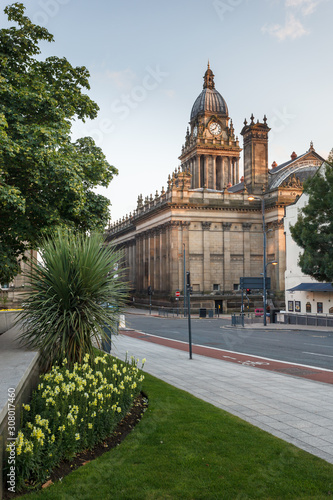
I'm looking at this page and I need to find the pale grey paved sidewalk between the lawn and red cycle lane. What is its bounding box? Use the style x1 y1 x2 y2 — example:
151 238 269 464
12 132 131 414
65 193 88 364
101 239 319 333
112 334 333 464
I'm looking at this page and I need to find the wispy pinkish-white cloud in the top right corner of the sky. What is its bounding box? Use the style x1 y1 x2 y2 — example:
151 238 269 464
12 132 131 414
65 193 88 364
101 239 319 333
261 0 325 42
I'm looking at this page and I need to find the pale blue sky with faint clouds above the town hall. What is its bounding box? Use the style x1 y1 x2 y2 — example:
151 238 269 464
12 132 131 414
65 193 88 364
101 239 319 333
0 0 333 222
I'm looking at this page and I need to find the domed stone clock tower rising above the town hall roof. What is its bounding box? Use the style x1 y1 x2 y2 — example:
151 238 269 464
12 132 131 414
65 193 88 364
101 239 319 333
179 63 241 191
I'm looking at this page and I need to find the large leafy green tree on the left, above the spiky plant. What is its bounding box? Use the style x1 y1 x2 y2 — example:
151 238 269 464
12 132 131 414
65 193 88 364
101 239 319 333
0 3 117 282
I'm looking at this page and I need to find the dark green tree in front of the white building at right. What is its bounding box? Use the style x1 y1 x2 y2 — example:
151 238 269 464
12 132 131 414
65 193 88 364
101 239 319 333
290 150 333 282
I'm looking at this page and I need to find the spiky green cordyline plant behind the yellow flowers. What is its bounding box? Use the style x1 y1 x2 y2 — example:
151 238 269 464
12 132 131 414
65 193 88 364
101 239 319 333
19 231 128 369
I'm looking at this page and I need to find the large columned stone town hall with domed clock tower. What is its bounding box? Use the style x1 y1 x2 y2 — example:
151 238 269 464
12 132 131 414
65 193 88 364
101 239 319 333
107 64 324 309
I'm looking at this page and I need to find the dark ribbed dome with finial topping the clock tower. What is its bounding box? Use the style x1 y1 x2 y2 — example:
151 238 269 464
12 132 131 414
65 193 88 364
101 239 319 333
191 63 228 121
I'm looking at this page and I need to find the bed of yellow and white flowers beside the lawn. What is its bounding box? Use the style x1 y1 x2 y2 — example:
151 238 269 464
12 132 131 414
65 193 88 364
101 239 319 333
7 354 145 490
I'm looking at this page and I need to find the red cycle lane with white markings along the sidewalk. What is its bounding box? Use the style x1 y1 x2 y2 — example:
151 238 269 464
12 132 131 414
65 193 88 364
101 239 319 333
121 330 333 384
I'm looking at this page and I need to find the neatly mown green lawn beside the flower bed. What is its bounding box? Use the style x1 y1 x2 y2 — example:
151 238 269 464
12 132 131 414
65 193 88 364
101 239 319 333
24 375 333 500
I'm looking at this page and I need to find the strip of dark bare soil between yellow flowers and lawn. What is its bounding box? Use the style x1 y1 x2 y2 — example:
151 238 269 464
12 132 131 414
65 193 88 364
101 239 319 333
3 393 148 500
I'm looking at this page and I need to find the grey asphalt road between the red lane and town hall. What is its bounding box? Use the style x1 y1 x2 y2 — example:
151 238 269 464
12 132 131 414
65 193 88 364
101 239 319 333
126 314 333 370
